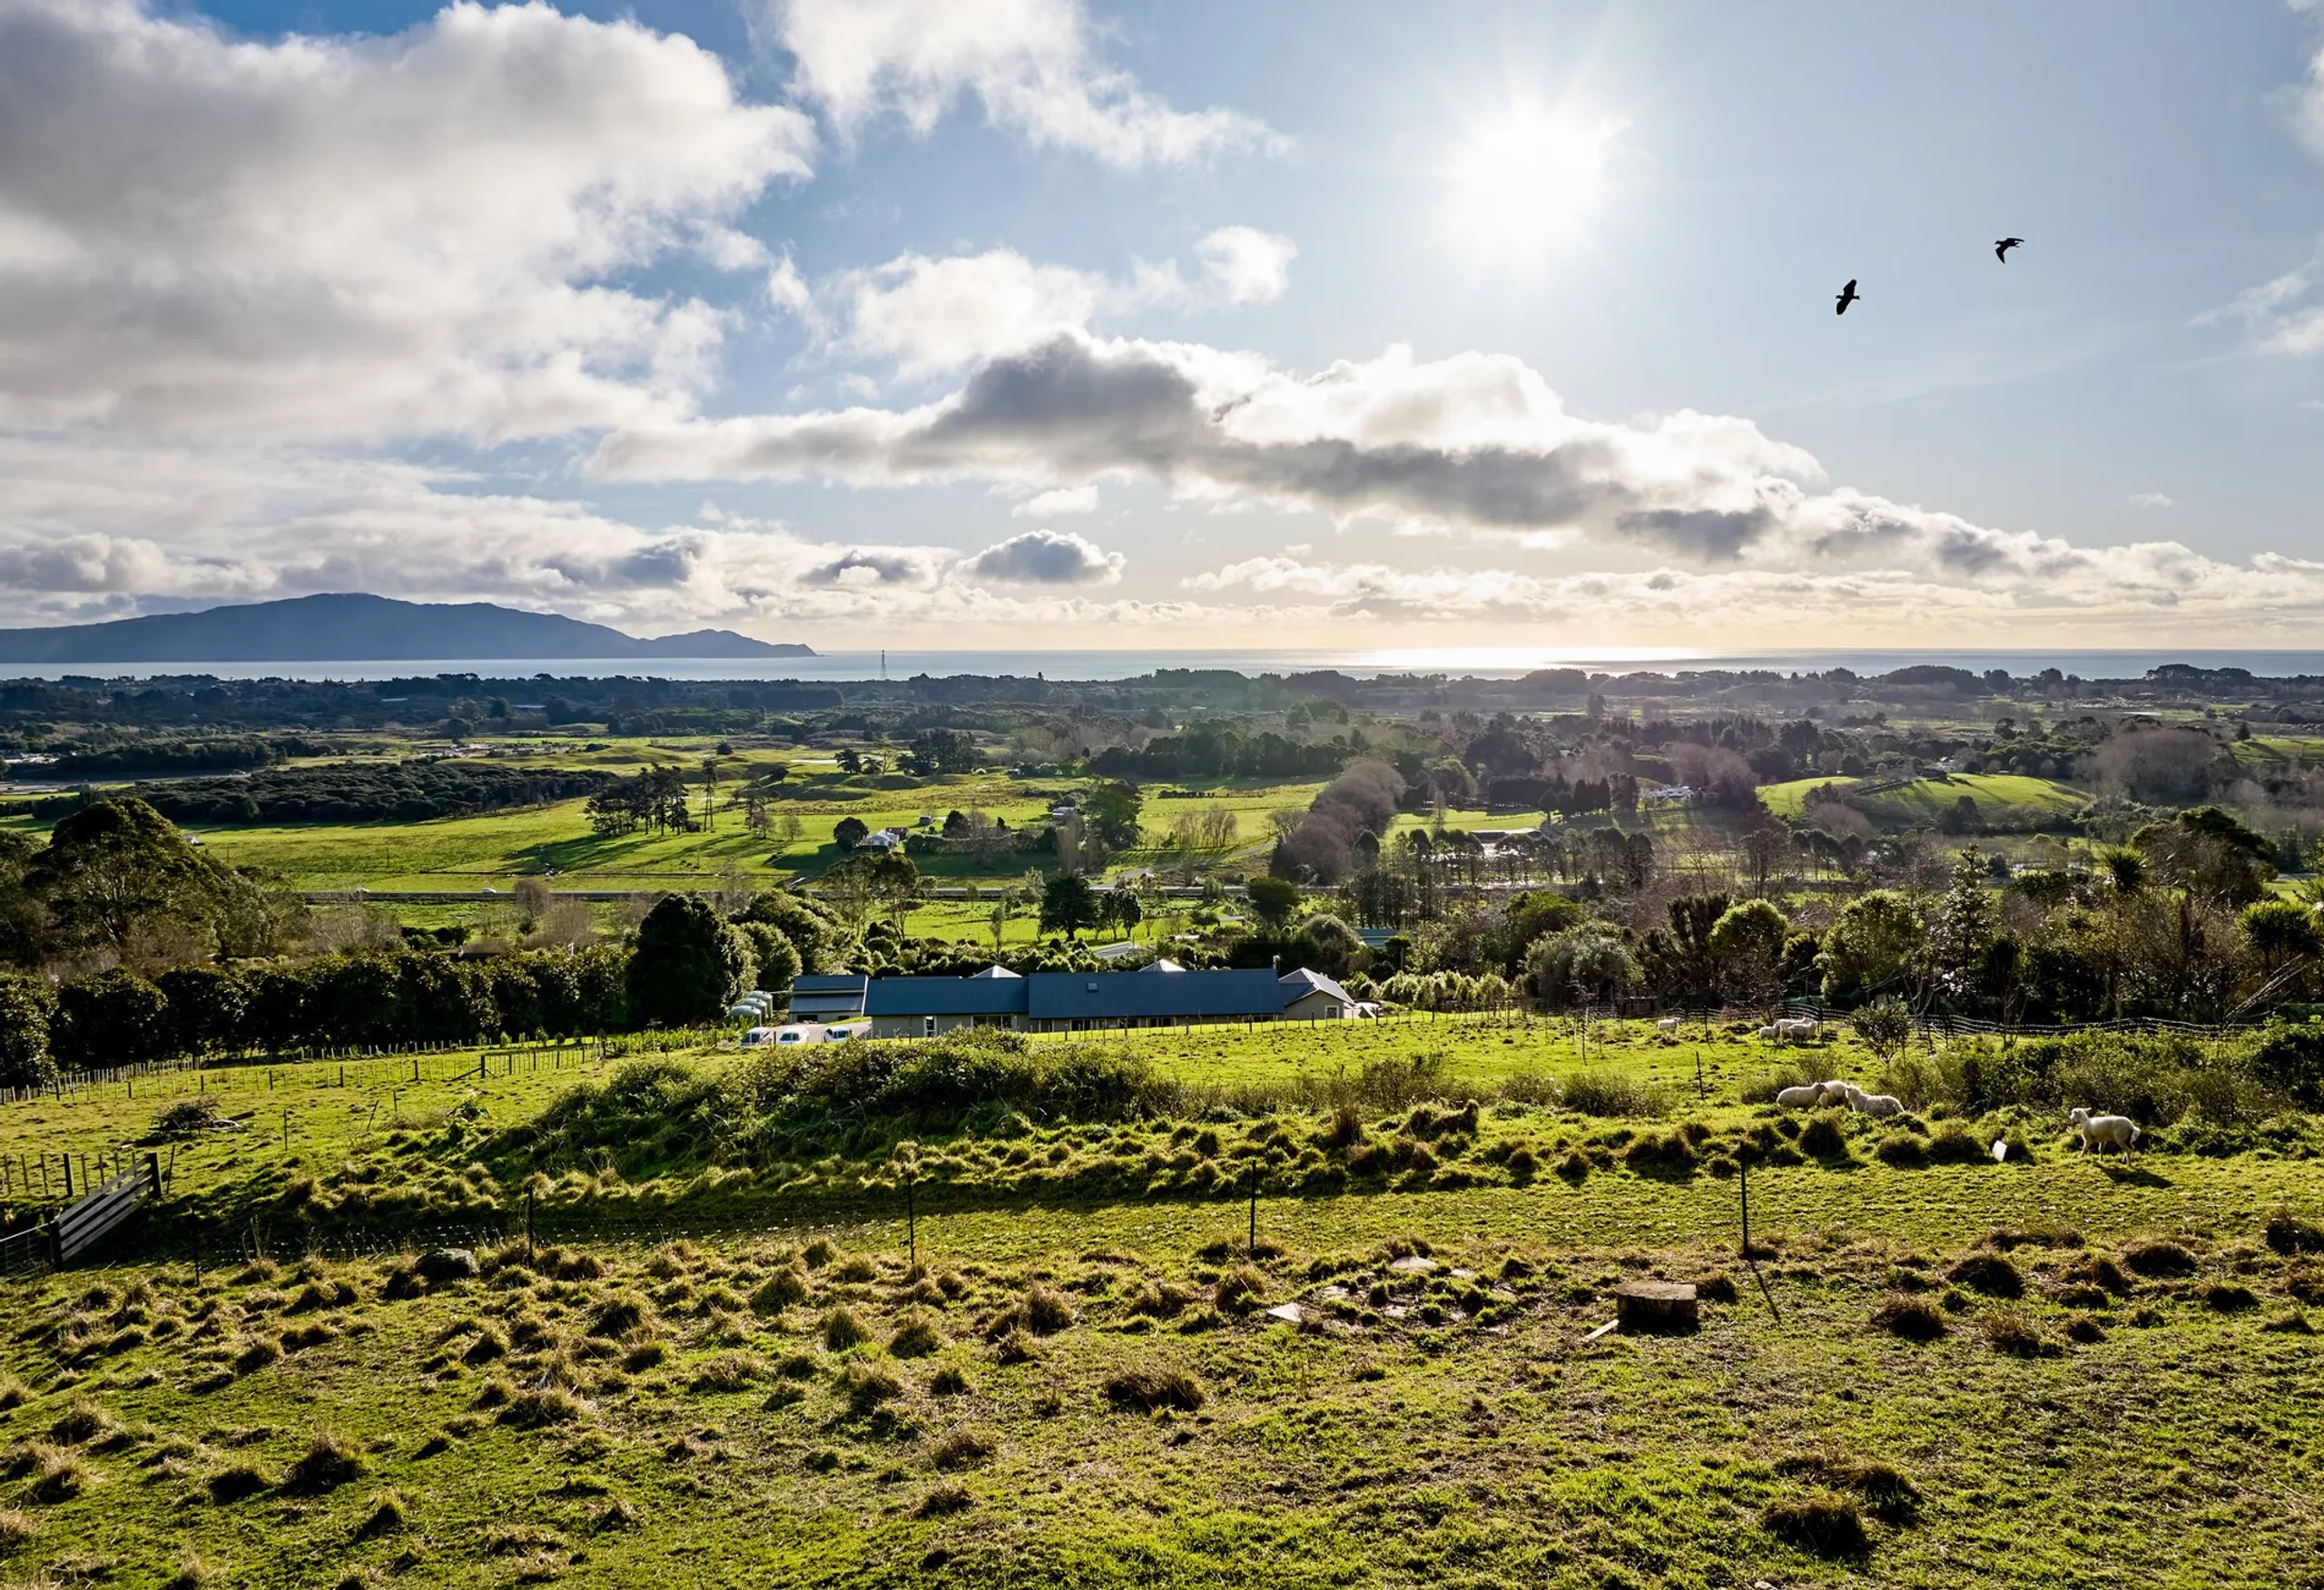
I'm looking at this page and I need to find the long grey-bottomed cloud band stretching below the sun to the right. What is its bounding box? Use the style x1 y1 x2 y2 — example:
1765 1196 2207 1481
593 332 2319 612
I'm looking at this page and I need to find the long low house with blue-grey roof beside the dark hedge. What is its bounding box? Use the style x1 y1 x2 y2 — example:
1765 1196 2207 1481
841 960 1354 1039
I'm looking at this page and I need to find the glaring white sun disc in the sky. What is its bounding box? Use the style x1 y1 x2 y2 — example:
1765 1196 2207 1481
1450 112 1622 256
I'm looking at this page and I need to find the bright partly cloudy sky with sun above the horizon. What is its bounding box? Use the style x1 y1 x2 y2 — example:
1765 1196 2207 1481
0 0 2324 658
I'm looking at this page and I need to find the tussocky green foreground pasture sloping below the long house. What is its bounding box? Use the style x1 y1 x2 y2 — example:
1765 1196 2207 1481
0 1018 2324 1590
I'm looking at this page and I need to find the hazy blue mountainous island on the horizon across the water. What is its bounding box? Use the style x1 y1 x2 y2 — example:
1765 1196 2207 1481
0 593 816 662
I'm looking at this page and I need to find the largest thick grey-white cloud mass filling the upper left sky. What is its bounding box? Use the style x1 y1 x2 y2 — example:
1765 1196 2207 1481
0 0 813 442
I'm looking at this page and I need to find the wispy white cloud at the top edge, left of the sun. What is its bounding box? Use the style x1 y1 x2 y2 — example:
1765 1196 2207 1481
773 0 1283 167
